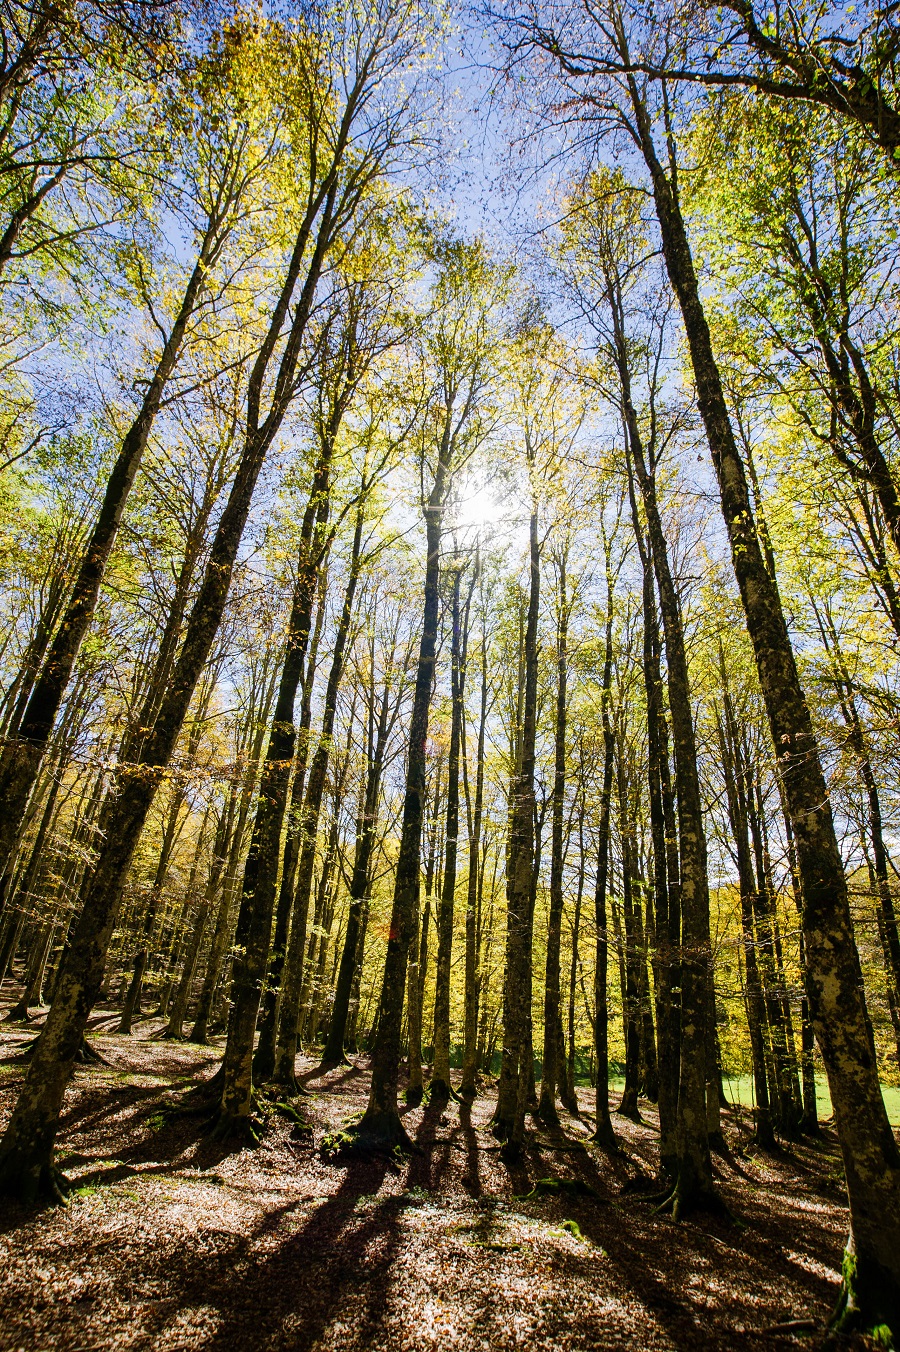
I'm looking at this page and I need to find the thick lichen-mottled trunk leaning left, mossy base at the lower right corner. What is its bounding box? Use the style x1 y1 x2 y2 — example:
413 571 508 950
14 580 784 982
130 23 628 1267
628 92 900 1328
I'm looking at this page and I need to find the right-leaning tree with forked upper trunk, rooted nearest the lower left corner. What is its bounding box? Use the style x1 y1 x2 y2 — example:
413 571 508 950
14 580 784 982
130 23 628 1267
0 5 432 1195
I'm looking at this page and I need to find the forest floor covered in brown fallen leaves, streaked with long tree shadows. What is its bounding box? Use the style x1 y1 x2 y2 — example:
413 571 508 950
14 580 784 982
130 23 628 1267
0 992 881 1352
